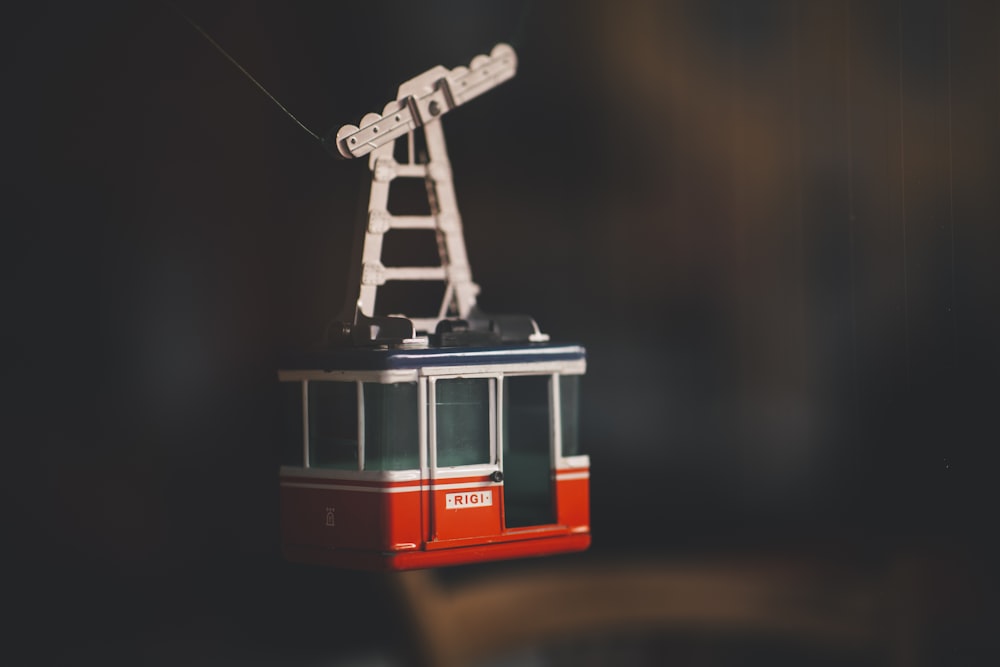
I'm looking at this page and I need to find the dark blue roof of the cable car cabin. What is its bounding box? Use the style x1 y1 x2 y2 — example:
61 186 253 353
281 343 587 371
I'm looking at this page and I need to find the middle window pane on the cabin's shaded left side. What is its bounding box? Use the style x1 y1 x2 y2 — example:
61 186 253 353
309 382 358 470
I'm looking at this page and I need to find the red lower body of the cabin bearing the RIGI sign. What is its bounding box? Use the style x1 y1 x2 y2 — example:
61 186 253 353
281 471 590 570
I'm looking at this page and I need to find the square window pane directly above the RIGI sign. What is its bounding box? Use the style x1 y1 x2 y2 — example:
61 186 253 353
435 378 492 467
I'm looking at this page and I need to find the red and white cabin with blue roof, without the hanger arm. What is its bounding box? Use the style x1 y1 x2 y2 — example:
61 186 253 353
279 344 590 570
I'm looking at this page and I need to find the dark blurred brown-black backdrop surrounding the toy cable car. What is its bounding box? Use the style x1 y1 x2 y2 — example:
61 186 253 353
0 0 1000 665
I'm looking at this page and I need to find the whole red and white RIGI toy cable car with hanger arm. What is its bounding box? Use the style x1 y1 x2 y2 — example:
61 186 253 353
278 44 590 570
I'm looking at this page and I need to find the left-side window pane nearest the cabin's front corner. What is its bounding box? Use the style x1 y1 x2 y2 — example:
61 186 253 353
364 382 420 470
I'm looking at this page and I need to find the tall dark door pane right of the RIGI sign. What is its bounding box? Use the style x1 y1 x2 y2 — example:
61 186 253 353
503 375 556 528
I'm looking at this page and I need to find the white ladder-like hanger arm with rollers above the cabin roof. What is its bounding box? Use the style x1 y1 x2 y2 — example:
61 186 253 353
336 44 548 345
